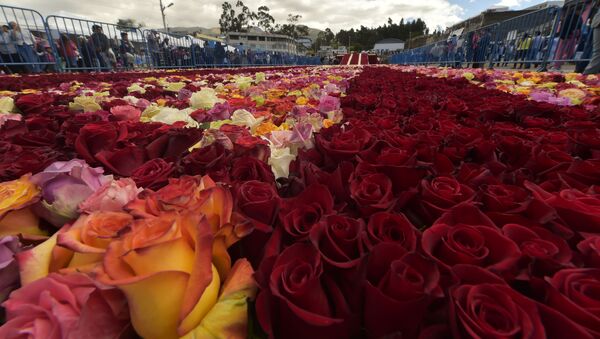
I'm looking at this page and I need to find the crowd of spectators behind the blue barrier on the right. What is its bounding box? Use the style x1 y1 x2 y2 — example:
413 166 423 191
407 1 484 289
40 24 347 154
389 1 600 73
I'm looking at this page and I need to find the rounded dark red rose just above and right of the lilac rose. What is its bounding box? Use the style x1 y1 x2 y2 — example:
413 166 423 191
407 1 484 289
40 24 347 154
75 122 119 164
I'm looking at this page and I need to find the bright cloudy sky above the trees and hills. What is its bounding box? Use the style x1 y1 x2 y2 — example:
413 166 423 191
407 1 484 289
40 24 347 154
2 0 543 31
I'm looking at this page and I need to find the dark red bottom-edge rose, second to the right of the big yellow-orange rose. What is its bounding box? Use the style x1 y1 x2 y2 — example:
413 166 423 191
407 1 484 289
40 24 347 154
364 243 444 338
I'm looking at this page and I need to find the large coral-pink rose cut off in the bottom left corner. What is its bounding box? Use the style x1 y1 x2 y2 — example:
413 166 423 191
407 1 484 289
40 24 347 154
0 273 130 339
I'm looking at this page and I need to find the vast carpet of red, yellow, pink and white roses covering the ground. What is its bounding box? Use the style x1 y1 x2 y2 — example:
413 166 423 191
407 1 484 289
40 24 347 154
0 66 600 338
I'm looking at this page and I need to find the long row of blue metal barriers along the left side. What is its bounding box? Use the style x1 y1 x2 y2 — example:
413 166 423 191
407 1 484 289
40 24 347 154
0 5 321 74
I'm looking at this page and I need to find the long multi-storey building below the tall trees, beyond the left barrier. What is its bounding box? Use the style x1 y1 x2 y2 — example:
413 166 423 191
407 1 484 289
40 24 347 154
225 28 298 54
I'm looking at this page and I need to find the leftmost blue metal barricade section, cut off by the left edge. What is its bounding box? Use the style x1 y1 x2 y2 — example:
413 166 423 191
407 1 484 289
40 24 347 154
0 5 56 73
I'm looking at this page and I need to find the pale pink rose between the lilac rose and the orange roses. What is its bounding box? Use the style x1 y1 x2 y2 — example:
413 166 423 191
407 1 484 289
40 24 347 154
79 178 142 213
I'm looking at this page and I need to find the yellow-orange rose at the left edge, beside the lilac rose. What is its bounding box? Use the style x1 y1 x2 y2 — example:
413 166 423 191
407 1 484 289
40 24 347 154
0 175 46 237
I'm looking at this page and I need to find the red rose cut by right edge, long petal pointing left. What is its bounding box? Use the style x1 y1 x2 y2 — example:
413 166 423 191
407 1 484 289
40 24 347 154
525 182 600 233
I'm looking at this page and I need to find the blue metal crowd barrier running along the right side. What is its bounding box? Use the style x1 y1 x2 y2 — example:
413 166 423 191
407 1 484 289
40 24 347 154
388 1 598 71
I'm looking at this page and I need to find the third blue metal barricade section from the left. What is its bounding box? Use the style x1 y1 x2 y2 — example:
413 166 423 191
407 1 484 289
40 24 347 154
143 30 193 68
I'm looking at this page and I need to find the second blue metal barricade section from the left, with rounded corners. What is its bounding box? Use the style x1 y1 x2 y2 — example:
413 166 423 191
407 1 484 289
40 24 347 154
46 15 149 71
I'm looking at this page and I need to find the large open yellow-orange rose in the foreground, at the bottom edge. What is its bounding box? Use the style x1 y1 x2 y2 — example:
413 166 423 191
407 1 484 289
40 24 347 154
99 213 221 339
